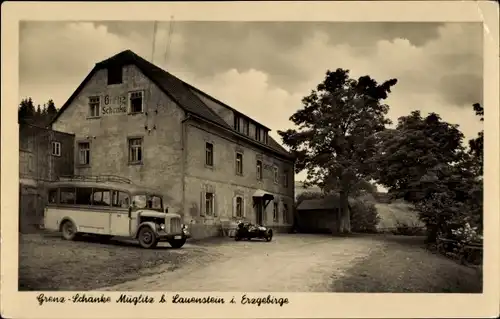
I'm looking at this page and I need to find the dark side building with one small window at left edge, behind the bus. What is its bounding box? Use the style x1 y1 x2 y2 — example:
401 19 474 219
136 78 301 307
19 123 75 232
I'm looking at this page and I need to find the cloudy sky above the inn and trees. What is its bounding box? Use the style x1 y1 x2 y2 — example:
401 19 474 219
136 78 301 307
19 20 483 185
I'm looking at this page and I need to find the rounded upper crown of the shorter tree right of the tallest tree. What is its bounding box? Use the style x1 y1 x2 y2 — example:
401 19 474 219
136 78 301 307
372 111 464 202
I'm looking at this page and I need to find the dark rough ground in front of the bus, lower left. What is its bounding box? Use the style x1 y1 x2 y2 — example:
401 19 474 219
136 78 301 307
19 234 207 291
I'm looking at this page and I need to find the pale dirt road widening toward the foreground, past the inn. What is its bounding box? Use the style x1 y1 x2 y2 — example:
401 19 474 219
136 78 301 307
101 234 382 292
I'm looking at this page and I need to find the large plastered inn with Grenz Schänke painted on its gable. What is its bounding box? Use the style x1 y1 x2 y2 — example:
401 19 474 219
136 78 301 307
48 50 294 238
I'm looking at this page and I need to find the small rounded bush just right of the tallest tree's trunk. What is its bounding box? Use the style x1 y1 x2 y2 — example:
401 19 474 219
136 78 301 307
350 199 380 233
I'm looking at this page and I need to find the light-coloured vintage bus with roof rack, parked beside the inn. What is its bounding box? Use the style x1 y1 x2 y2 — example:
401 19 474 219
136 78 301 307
44 175 190 248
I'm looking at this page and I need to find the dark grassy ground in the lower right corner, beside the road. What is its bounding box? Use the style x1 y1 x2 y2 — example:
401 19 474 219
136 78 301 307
332 235 482 293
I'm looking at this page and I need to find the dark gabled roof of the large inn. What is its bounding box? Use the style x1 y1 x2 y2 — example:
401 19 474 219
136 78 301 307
51 50 293 159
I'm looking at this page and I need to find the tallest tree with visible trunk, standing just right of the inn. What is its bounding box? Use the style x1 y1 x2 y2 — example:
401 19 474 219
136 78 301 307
278 69 397 232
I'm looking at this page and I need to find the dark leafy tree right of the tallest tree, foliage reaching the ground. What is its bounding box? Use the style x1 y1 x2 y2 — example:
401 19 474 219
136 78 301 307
372 111 482 242
